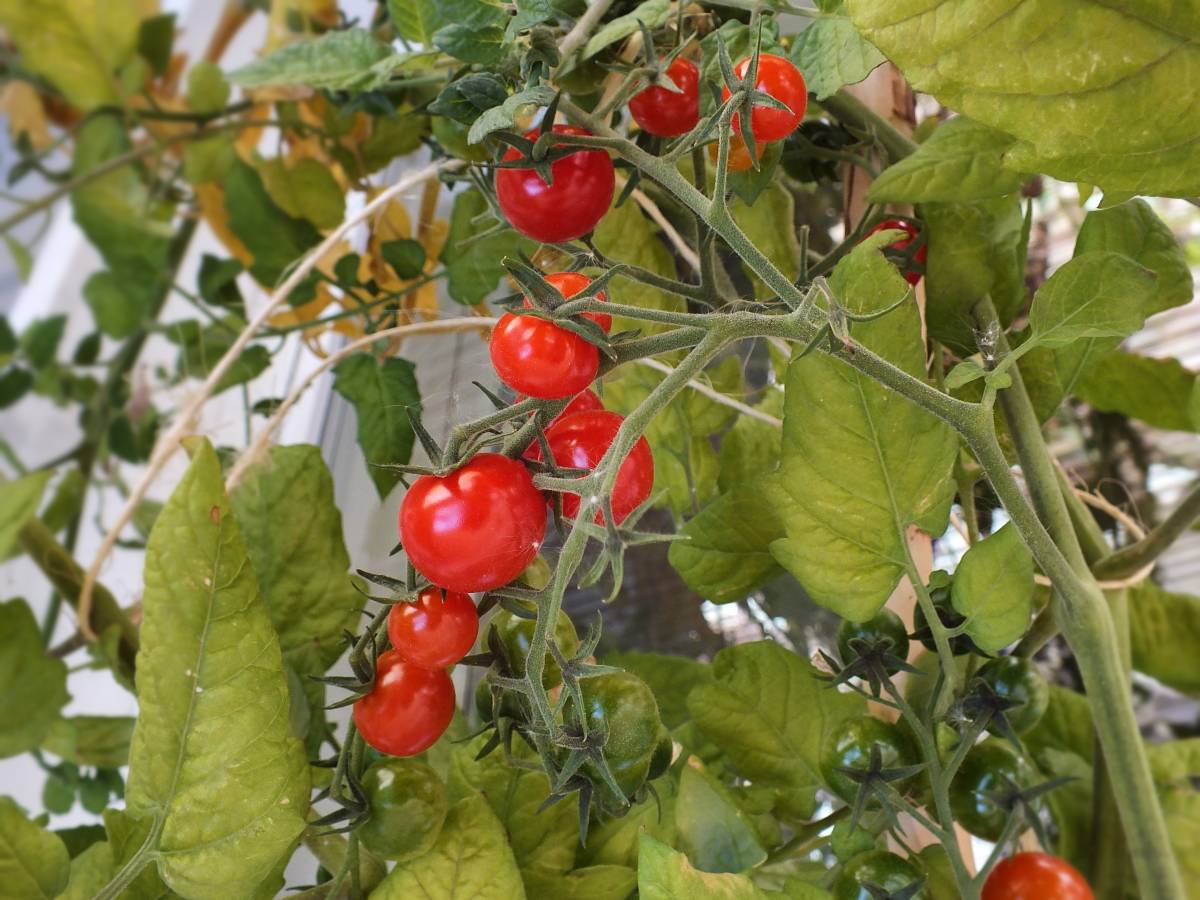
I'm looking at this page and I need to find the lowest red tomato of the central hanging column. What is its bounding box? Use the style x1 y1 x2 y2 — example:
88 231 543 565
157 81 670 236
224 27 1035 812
354 650 454 756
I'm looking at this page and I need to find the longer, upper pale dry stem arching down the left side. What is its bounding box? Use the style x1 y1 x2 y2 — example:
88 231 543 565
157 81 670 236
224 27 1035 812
78 160 463 641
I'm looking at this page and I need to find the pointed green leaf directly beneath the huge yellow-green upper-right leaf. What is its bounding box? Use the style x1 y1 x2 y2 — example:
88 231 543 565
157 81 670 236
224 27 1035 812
866 116 1021 203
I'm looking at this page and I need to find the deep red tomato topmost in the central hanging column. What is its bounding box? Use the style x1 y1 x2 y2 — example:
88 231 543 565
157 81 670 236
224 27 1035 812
496 125 616 244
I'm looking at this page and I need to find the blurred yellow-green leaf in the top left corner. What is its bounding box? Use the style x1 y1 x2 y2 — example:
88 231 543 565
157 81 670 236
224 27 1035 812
0 0 145 112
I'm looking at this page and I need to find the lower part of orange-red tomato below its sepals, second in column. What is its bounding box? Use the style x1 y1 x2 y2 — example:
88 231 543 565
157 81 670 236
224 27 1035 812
490 312 600 400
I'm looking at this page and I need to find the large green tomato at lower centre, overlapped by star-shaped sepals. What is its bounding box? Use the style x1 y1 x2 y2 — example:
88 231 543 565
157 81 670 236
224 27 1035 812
566 672 662 805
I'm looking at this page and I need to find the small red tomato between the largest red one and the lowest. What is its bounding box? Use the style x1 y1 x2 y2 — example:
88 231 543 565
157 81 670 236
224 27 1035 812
388 588 479 668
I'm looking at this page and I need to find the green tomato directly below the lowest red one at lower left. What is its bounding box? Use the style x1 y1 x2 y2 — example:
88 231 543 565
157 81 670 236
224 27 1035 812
356 757 448 859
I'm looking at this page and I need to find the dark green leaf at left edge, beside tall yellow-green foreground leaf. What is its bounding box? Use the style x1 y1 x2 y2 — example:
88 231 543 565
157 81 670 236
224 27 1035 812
0 600 70 758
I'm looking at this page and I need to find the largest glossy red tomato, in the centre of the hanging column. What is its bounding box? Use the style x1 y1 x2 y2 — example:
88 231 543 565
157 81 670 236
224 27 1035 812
400 454 546 593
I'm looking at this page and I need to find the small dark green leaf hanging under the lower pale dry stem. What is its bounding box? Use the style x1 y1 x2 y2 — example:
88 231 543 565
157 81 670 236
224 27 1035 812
334 353 421 499
